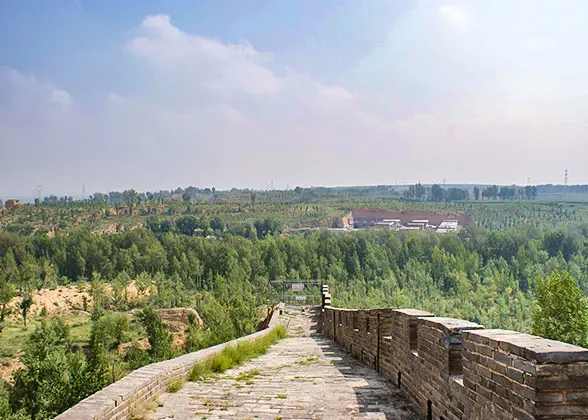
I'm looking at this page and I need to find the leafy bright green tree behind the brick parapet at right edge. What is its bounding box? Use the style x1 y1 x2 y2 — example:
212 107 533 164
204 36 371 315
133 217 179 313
533 271 588 347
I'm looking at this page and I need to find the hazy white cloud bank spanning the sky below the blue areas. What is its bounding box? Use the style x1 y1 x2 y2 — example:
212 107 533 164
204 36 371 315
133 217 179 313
0 5 588 194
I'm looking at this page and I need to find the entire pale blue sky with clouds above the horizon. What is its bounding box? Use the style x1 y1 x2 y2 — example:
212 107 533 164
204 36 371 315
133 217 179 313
0 0 588 198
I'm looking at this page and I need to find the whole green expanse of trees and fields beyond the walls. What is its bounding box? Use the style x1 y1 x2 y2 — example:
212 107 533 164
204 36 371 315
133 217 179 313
0 191 588 419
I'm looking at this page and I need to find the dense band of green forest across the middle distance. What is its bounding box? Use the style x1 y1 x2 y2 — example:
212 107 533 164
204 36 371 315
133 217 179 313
0 224 588 329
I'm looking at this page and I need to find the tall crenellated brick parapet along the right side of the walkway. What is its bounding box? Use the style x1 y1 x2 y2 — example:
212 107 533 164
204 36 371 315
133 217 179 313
321 306 588 420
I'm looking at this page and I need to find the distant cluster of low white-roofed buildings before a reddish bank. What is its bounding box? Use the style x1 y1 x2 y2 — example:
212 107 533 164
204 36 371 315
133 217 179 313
348 208 474 232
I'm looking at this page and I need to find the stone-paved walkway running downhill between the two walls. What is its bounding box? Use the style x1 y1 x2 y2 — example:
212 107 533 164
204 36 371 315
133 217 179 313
144 309 419 420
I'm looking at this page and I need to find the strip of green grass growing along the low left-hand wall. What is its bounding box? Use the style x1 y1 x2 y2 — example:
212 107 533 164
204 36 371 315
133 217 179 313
188 325 288 381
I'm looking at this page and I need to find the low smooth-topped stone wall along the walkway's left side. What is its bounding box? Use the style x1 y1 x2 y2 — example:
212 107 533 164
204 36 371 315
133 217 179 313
55 311 280 420
